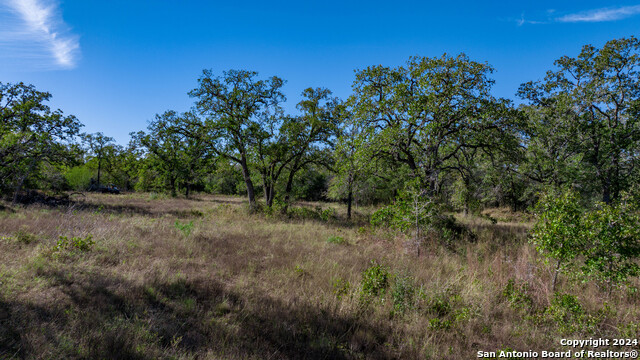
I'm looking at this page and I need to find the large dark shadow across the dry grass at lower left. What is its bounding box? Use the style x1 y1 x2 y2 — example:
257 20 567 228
0 269 391 359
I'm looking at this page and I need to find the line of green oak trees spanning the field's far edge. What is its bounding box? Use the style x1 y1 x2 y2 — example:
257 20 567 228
0 37 640 214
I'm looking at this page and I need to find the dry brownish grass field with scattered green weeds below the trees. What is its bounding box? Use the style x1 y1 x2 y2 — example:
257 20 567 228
0 194 640 359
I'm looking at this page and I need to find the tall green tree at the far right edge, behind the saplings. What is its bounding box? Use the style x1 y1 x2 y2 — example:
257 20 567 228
519 37 640 203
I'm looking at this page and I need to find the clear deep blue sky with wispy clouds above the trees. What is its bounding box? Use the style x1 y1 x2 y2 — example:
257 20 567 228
0 0 640 144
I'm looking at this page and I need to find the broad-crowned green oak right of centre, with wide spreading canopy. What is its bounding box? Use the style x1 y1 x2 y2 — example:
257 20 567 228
350 55 517 194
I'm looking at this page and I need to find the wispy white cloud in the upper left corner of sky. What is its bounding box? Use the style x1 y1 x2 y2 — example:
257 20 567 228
0 0 80 68
